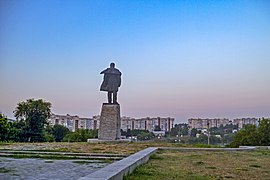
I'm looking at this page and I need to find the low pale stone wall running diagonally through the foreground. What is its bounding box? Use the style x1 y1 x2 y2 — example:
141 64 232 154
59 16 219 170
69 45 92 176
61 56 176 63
79 147 158 180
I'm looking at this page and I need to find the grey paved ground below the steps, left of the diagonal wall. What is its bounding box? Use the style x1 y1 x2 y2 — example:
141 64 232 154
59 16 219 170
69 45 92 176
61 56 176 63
0 157 108 180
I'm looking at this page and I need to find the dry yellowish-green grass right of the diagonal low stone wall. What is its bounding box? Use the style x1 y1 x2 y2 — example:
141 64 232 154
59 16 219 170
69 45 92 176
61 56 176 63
125 150 270 180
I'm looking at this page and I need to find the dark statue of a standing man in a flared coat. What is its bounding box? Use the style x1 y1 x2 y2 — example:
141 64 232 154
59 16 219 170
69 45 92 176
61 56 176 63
100 63 122 104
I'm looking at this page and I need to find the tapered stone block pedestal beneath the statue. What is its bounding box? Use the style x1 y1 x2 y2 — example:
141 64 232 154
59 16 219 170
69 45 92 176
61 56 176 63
98 103 121 140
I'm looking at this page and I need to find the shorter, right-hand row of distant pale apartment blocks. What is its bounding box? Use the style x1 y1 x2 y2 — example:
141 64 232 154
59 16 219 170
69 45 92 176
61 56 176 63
188 118 259 129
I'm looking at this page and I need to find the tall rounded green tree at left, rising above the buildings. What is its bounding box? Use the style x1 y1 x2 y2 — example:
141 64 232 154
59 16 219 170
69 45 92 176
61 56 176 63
14 99 51 142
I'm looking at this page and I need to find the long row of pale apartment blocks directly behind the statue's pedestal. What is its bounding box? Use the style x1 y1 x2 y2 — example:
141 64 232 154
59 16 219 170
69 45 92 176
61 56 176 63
49 114 174 132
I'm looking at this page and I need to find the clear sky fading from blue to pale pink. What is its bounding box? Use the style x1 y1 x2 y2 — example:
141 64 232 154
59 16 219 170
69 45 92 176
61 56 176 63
0 0 270 122
